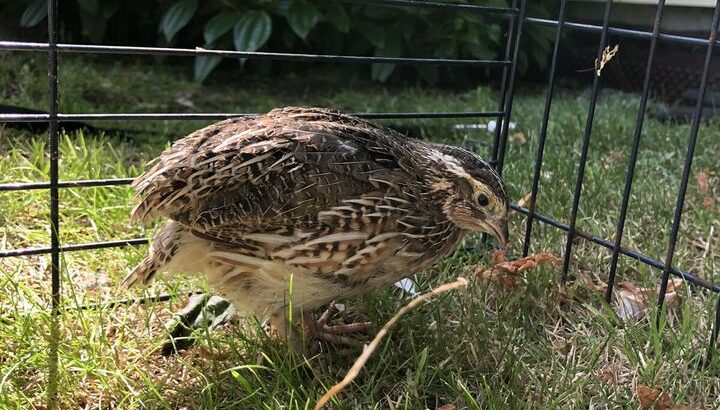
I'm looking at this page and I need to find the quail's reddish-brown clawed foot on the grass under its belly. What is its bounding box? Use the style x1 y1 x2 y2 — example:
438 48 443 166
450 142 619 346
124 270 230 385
303 302 372 355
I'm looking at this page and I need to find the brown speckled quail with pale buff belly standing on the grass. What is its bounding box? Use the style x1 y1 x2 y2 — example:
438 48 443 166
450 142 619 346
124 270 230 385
124 107 508 350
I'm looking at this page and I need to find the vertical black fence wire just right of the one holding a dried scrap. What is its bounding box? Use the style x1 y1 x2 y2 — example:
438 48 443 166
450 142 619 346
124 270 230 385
605 0 665 302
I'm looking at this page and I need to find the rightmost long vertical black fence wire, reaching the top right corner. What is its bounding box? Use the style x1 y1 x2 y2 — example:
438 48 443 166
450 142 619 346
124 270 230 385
657 0 720 318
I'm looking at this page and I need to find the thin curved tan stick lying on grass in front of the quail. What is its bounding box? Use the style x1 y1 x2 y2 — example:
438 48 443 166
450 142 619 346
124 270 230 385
315 278 468 410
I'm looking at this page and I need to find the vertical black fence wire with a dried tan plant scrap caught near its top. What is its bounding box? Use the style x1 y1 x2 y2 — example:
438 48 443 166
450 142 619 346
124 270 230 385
562 0 612 282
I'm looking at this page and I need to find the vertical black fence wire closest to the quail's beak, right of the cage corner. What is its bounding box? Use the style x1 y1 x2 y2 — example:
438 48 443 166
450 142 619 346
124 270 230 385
523 0 567 256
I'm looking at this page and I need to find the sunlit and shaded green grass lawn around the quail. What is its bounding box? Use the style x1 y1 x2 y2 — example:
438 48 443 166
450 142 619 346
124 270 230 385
0 53 720 409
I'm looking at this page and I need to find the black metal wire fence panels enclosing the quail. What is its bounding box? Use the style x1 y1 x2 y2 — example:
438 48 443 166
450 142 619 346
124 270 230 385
0 0 720 404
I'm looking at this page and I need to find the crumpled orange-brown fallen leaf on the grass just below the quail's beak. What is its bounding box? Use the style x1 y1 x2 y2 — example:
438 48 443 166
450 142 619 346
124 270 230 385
475 250 562 288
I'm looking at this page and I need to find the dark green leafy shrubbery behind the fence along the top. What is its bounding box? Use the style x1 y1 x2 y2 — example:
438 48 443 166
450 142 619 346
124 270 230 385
11 0 555 84
